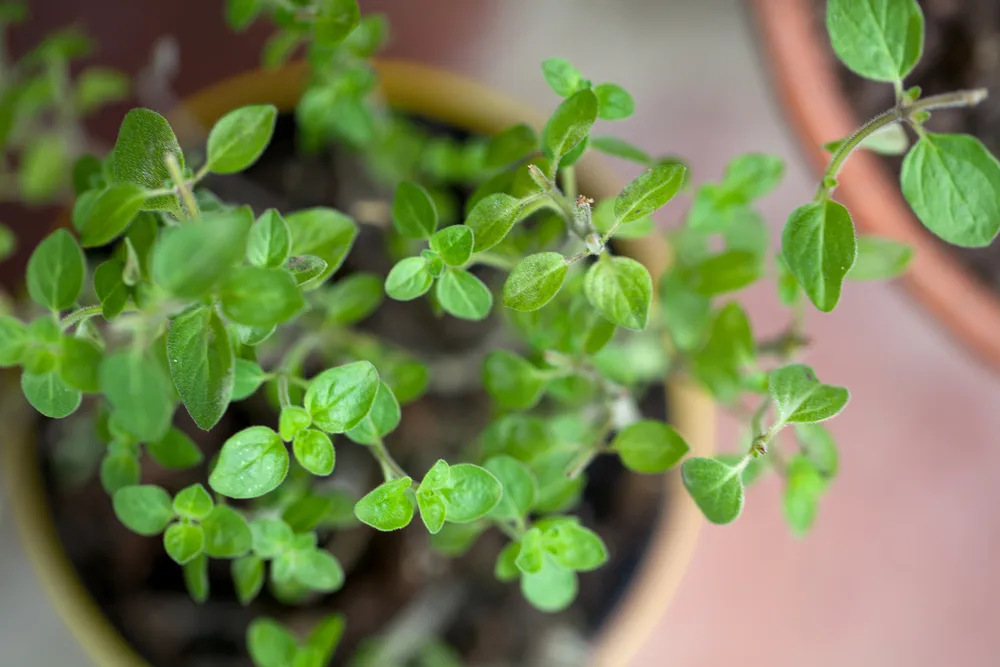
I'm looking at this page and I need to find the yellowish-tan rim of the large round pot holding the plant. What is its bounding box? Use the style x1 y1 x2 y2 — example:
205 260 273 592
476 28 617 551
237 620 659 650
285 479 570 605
0 61 715 667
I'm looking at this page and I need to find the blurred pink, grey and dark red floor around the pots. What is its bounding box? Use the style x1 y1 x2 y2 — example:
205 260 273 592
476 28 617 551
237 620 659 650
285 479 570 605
0 0 1000 667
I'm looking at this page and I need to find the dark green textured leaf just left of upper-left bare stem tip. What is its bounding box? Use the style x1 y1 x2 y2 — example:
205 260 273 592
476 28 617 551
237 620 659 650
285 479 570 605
113 109 184 211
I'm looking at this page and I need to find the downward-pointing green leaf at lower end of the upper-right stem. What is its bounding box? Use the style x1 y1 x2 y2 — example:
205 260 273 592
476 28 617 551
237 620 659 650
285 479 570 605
781 200 858 313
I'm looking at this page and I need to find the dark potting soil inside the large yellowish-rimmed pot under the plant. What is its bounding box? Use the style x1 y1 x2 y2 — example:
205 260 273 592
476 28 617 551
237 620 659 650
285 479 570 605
39 117 666 667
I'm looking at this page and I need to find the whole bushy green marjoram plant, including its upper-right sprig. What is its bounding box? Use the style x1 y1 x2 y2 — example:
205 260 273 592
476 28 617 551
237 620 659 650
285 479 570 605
0 0 1000 667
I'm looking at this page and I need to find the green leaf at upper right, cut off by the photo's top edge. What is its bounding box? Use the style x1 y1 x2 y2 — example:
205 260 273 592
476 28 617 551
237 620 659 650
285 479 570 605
826 0 924 83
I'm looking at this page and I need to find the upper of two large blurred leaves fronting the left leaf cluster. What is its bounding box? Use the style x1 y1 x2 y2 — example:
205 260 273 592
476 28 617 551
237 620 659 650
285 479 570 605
152 209 253 299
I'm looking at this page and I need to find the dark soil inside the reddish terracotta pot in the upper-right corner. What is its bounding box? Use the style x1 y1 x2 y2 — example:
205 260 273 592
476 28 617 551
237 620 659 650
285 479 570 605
816 0 1000 292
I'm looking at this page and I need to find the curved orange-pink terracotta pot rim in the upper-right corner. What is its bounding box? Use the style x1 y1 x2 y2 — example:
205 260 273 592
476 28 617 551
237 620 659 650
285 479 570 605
753 0 1000 369
